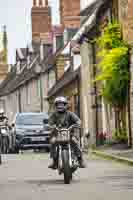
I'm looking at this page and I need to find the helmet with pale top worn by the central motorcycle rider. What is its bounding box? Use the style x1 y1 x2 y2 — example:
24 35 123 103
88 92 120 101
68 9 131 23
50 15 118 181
54 97 68 113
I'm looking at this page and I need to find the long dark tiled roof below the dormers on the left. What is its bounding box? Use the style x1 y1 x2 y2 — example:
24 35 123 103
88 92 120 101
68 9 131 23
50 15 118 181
0 45 55 96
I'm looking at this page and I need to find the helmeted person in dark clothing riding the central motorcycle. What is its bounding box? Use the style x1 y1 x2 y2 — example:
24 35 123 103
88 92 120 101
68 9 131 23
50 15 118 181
49 97 85 169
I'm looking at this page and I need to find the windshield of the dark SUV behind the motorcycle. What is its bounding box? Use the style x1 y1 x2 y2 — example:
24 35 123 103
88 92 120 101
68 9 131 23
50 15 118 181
16 114 48 125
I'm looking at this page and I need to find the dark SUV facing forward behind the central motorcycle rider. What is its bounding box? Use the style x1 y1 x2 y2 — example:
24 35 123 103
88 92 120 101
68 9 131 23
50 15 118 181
13 113 50 153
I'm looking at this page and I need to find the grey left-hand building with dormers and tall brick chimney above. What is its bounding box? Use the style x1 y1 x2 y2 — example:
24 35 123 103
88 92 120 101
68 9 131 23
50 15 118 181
0 0 55 122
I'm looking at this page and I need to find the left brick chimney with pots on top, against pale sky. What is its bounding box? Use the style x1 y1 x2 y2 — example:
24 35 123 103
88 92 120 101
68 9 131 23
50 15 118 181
31 0 52 42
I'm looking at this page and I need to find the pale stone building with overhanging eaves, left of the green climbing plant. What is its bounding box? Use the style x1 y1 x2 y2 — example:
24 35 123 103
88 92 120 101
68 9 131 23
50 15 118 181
72 0 118 146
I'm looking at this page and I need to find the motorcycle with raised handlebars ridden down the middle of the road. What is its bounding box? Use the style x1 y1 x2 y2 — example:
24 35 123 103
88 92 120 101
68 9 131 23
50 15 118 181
50 125 79 184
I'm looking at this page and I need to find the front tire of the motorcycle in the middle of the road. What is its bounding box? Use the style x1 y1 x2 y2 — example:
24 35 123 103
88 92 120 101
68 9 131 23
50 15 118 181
62 150 72 184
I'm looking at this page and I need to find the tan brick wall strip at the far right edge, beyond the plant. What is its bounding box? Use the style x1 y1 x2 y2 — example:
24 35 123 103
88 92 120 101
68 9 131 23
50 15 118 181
117 0 133 146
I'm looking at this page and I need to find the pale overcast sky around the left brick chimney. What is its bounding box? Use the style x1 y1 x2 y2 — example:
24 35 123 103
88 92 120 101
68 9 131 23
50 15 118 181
0 0 59 64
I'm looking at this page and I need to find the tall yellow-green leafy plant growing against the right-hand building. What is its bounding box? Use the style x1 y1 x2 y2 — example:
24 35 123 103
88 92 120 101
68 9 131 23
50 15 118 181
95 22 129 137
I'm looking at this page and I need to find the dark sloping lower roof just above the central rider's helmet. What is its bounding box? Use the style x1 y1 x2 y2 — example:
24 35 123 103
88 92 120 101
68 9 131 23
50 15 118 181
48 69 80 98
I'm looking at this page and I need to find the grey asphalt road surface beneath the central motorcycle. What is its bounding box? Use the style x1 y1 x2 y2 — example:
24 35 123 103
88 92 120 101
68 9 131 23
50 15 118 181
0 153 133 200
